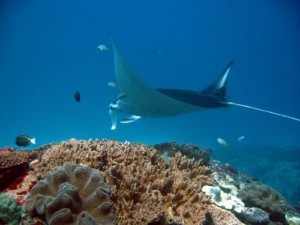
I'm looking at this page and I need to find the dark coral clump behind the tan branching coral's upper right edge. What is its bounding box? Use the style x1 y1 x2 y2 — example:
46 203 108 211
153 141 211 165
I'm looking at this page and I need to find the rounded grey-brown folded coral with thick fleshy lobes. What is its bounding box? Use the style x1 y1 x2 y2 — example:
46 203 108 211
25 164 116 225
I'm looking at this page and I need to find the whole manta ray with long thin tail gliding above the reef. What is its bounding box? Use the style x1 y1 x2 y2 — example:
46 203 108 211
109 41 300 130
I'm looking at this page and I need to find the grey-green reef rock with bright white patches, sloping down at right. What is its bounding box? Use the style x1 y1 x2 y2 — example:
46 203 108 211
209 161 299 225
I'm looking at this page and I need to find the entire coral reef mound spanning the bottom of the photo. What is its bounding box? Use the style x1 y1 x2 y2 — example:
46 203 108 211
0 139 300 225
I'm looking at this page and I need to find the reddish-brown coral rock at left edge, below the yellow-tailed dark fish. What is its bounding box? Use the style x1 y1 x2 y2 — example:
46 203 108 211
0 148 31 191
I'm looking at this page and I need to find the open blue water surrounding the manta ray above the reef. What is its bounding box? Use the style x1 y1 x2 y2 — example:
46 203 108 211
0 0 300 205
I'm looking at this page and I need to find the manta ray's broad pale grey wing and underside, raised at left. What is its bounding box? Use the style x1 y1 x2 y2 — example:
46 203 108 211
113 43 202 117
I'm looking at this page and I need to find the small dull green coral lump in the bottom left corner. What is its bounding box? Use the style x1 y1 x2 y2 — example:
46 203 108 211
0 194 24 225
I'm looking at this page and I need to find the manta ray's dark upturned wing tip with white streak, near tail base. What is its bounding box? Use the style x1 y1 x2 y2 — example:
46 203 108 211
201 61 234 99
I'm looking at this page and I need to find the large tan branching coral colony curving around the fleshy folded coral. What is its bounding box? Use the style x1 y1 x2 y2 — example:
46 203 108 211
29 139 241 225
